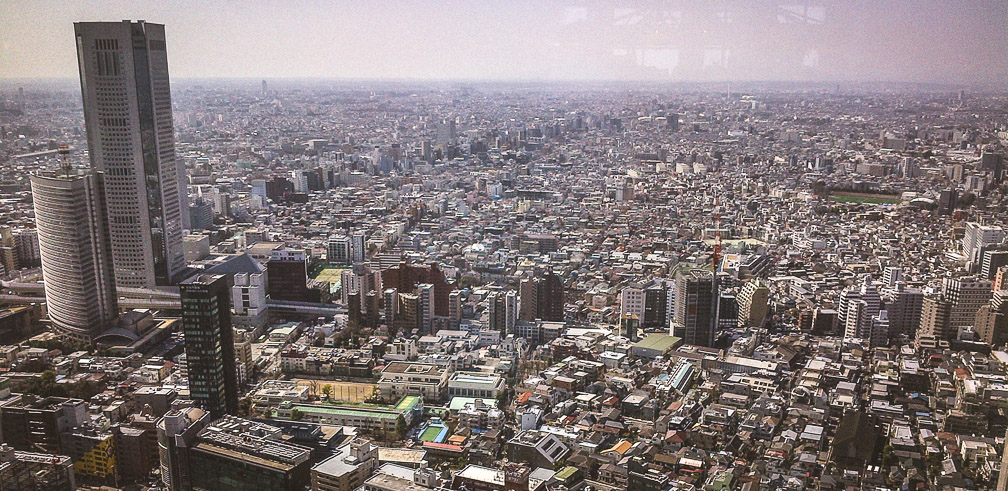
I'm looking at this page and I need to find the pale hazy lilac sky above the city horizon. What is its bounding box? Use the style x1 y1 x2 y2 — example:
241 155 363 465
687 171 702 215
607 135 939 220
0 0 1008 87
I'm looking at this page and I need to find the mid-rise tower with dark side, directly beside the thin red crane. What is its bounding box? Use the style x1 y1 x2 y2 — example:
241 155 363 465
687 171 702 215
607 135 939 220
671 269 718 346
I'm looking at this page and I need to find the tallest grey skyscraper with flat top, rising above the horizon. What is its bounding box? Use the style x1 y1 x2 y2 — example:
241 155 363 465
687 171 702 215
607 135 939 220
74 21 188 288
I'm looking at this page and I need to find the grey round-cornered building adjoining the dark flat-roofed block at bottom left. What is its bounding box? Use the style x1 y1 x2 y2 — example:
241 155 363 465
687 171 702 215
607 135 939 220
156 407 211 491
